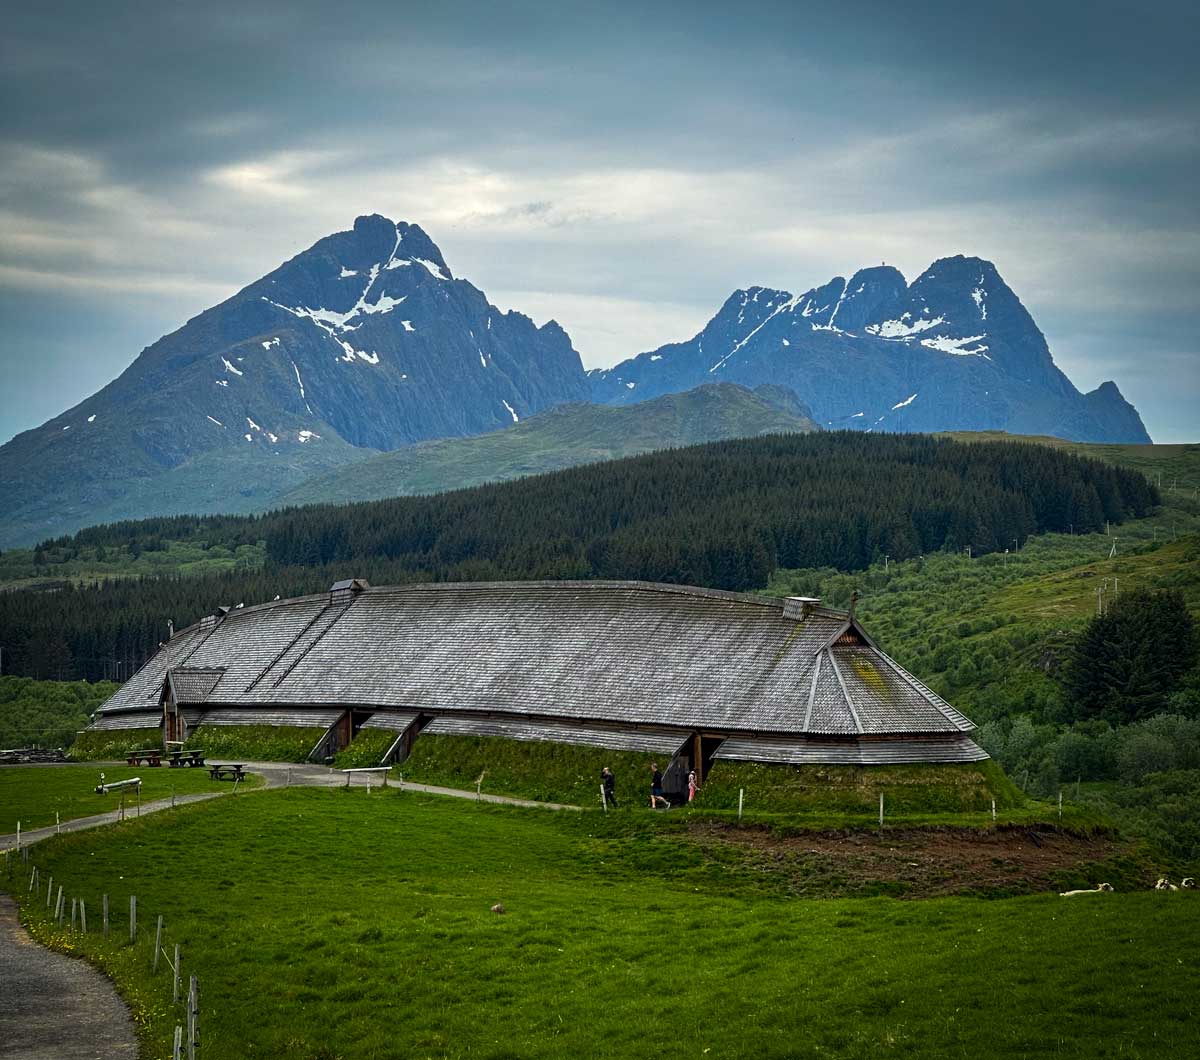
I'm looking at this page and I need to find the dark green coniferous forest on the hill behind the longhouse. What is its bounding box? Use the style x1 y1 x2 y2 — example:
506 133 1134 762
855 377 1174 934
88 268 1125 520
0 432 1159 679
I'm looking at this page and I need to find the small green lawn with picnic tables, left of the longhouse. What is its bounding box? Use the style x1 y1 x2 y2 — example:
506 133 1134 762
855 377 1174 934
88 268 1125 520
0 762 255 834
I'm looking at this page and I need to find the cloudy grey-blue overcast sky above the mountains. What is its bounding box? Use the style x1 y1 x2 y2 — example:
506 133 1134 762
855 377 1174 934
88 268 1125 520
0 0 1200 442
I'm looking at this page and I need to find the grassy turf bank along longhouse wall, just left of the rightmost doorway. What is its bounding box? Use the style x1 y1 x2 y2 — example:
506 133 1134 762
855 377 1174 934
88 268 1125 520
396 733 671 806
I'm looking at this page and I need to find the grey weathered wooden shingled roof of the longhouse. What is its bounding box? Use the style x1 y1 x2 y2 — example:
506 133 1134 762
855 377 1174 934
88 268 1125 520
91 581 974 737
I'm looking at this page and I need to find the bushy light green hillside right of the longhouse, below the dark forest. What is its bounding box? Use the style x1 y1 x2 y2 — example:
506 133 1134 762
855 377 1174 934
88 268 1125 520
768 435 1200 857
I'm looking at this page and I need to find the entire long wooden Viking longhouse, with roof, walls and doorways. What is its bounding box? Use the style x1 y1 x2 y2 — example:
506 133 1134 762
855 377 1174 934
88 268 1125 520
92 580 988 773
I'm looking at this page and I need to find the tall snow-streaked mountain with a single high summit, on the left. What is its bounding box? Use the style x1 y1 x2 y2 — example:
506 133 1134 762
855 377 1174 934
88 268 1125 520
0 215 588 546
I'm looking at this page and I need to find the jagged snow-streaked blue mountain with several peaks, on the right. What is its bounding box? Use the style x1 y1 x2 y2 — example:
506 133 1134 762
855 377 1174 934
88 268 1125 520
589 256 1150 442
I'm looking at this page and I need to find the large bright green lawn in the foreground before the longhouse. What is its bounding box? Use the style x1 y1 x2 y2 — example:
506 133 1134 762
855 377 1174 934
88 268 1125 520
0 789 1200 1060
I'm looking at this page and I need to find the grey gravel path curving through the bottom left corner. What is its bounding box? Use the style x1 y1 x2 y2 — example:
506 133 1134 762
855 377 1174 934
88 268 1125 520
0 894 138 1060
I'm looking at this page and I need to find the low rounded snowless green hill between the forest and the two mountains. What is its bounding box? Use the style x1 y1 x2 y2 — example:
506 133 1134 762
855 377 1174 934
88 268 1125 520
278 383 820 504
